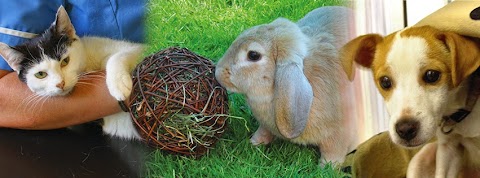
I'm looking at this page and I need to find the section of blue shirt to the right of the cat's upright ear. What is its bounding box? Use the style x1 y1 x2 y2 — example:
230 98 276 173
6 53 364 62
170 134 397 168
65 0 146 42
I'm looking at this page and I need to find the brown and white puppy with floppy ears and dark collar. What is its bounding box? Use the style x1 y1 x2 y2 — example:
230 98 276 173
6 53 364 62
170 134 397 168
341 26 480 177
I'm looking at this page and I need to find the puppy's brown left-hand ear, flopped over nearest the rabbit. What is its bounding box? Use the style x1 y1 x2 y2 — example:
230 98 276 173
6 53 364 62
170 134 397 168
340 34 383 80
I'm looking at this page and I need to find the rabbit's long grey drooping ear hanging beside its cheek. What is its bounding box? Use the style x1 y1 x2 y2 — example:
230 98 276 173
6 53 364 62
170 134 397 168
274 63 313 139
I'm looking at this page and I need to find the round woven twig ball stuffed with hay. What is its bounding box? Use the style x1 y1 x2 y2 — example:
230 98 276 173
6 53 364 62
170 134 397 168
127 47 228 157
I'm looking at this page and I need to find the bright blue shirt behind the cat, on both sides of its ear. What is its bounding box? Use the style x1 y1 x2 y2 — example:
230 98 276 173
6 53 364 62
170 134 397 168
0 0 146 71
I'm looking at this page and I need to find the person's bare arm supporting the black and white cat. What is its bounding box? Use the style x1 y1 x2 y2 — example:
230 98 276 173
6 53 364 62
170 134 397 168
0 70 121 130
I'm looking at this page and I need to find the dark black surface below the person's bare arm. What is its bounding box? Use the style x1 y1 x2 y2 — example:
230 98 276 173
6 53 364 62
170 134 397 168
0 123 152 178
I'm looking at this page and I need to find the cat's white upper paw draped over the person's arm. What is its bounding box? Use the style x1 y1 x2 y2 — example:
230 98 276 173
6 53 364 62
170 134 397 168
107 72 133 101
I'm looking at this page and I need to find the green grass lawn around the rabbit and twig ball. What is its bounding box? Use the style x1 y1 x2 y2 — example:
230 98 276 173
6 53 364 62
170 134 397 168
146 0 350 178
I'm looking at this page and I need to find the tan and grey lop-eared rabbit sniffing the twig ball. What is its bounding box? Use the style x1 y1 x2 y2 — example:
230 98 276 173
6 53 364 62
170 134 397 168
215 6 357 163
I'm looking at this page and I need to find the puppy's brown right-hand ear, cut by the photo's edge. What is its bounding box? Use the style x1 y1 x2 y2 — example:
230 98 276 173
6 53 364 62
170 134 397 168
436 32 480 87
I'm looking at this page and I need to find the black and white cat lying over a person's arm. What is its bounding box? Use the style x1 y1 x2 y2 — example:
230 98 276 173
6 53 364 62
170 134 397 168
0 6 143 139
